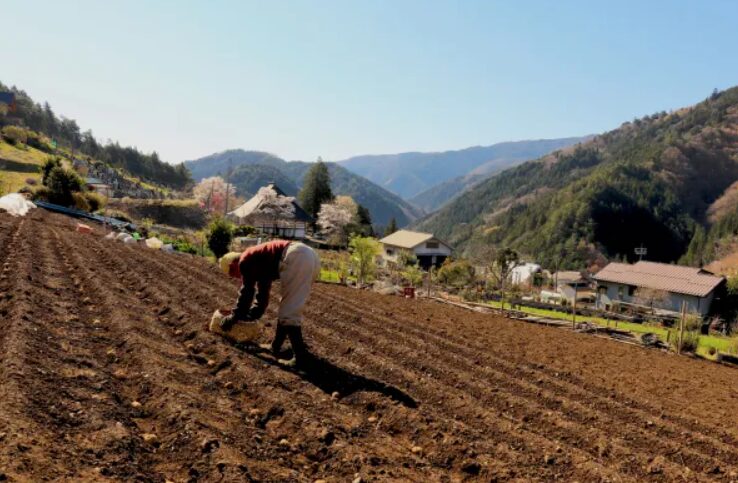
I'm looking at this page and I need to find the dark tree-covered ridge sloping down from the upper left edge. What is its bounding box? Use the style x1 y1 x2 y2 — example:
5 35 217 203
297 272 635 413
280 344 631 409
0 82 192 189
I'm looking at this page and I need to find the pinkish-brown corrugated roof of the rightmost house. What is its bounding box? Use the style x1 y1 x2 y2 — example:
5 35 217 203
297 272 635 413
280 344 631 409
594 261 724 297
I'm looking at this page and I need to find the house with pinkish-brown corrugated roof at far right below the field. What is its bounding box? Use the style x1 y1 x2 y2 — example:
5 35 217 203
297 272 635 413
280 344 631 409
594 261 725 316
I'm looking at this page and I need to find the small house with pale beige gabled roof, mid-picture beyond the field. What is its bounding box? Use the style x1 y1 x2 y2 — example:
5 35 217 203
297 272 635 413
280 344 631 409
379 230 453 270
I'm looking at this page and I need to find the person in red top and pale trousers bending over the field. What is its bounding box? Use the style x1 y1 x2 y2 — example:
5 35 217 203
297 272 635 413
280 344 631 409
220 240 320 364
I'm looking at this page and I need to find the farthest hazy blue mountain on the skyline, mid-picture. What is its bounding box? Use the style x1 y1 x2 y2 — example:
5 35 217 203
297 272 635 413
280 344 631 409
339 137 585 199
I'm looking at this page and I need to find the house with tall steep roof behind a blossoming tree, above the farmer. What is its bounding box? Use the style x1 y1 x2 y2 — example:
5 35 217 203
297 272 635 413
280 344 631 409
227 183 315 240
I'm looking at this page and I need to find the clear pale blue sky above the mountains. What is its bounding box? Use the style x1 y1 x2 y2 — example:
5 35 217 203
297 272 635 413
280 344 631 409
0 0 738 162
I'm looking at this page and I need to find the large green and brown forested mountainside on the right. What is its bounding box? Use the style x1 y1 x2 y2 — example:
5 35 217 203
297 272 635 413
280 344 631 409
417 88 738 268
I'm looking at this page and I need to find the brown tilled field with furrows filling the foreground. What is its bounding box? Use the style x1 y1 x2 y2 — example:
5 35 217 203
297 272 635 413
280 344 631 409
0 210 738 481
